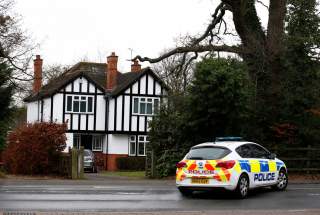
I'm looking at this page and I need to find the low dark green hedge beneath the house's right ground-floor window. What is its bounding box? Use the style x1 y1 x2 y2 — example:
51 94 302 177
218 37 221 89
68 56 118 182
116 157 146 171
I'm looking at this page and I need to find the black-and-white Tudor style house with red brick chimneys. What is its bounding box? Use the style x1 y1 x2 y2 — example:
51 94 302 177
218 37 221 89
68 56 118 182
24 53 167 170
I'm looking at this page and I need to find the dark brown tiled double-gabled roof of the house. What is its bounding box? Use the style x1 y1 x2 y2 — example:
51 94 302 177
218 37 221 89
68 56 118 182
24 62 168 102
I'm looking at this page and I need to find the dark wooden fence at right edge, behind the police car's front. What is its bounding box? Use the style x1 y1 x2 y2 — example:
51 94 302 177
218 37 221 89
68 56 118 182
271 146 320 173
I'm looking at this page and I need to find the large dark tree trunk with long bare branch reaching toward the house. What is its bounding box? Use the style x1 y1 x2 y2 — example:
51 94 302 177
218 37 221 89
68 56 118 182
133 0 287 117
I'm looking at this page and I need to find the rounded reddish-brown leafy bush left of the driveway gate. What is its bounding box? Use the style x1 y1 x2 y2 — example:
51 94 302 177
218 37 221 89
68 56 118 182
3 122 67 174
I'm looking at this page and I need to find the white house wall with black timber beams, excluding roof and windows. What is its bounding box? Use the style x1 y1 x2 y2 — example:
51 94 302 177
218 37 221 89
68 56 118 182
27 70 166 170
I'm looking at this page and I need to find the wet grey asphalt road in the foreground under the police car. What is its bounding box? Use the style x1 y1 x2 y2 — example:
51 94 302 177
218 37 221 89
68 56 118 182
0 178 320 214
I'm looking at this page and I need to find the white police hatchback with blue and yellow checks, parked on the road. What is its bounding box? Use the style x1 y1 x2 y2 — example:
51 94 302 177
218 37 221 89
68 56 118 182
176 138 288 198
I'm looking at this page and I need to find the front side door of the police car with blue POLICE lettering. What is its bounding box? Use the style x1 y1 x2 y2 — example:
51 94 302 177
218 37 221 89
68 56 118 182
249 144 276 186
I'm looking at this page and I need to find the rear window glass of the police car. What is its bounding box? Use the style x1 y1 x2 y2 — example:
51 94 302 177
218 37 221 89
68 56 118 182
186 146 231 160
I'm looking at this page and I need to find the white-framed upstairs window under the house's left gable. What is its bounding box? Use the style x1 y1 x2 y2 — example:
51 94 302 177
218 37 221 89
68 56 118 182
66 95 93 113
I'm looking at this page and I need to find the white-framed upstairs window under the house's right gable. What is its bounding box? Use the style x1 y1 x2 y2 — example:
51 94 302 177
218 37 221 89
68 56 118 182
132 97 160 115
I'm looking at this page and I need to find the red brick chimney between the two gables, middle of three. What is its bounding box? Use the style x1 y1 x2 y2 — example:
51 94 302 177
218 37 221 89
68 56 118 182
106 52 118 90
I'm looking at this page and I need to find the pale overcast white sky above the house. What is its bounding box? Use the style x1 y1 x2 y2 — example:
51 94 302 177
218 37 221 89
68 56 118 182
15 0 225 71
